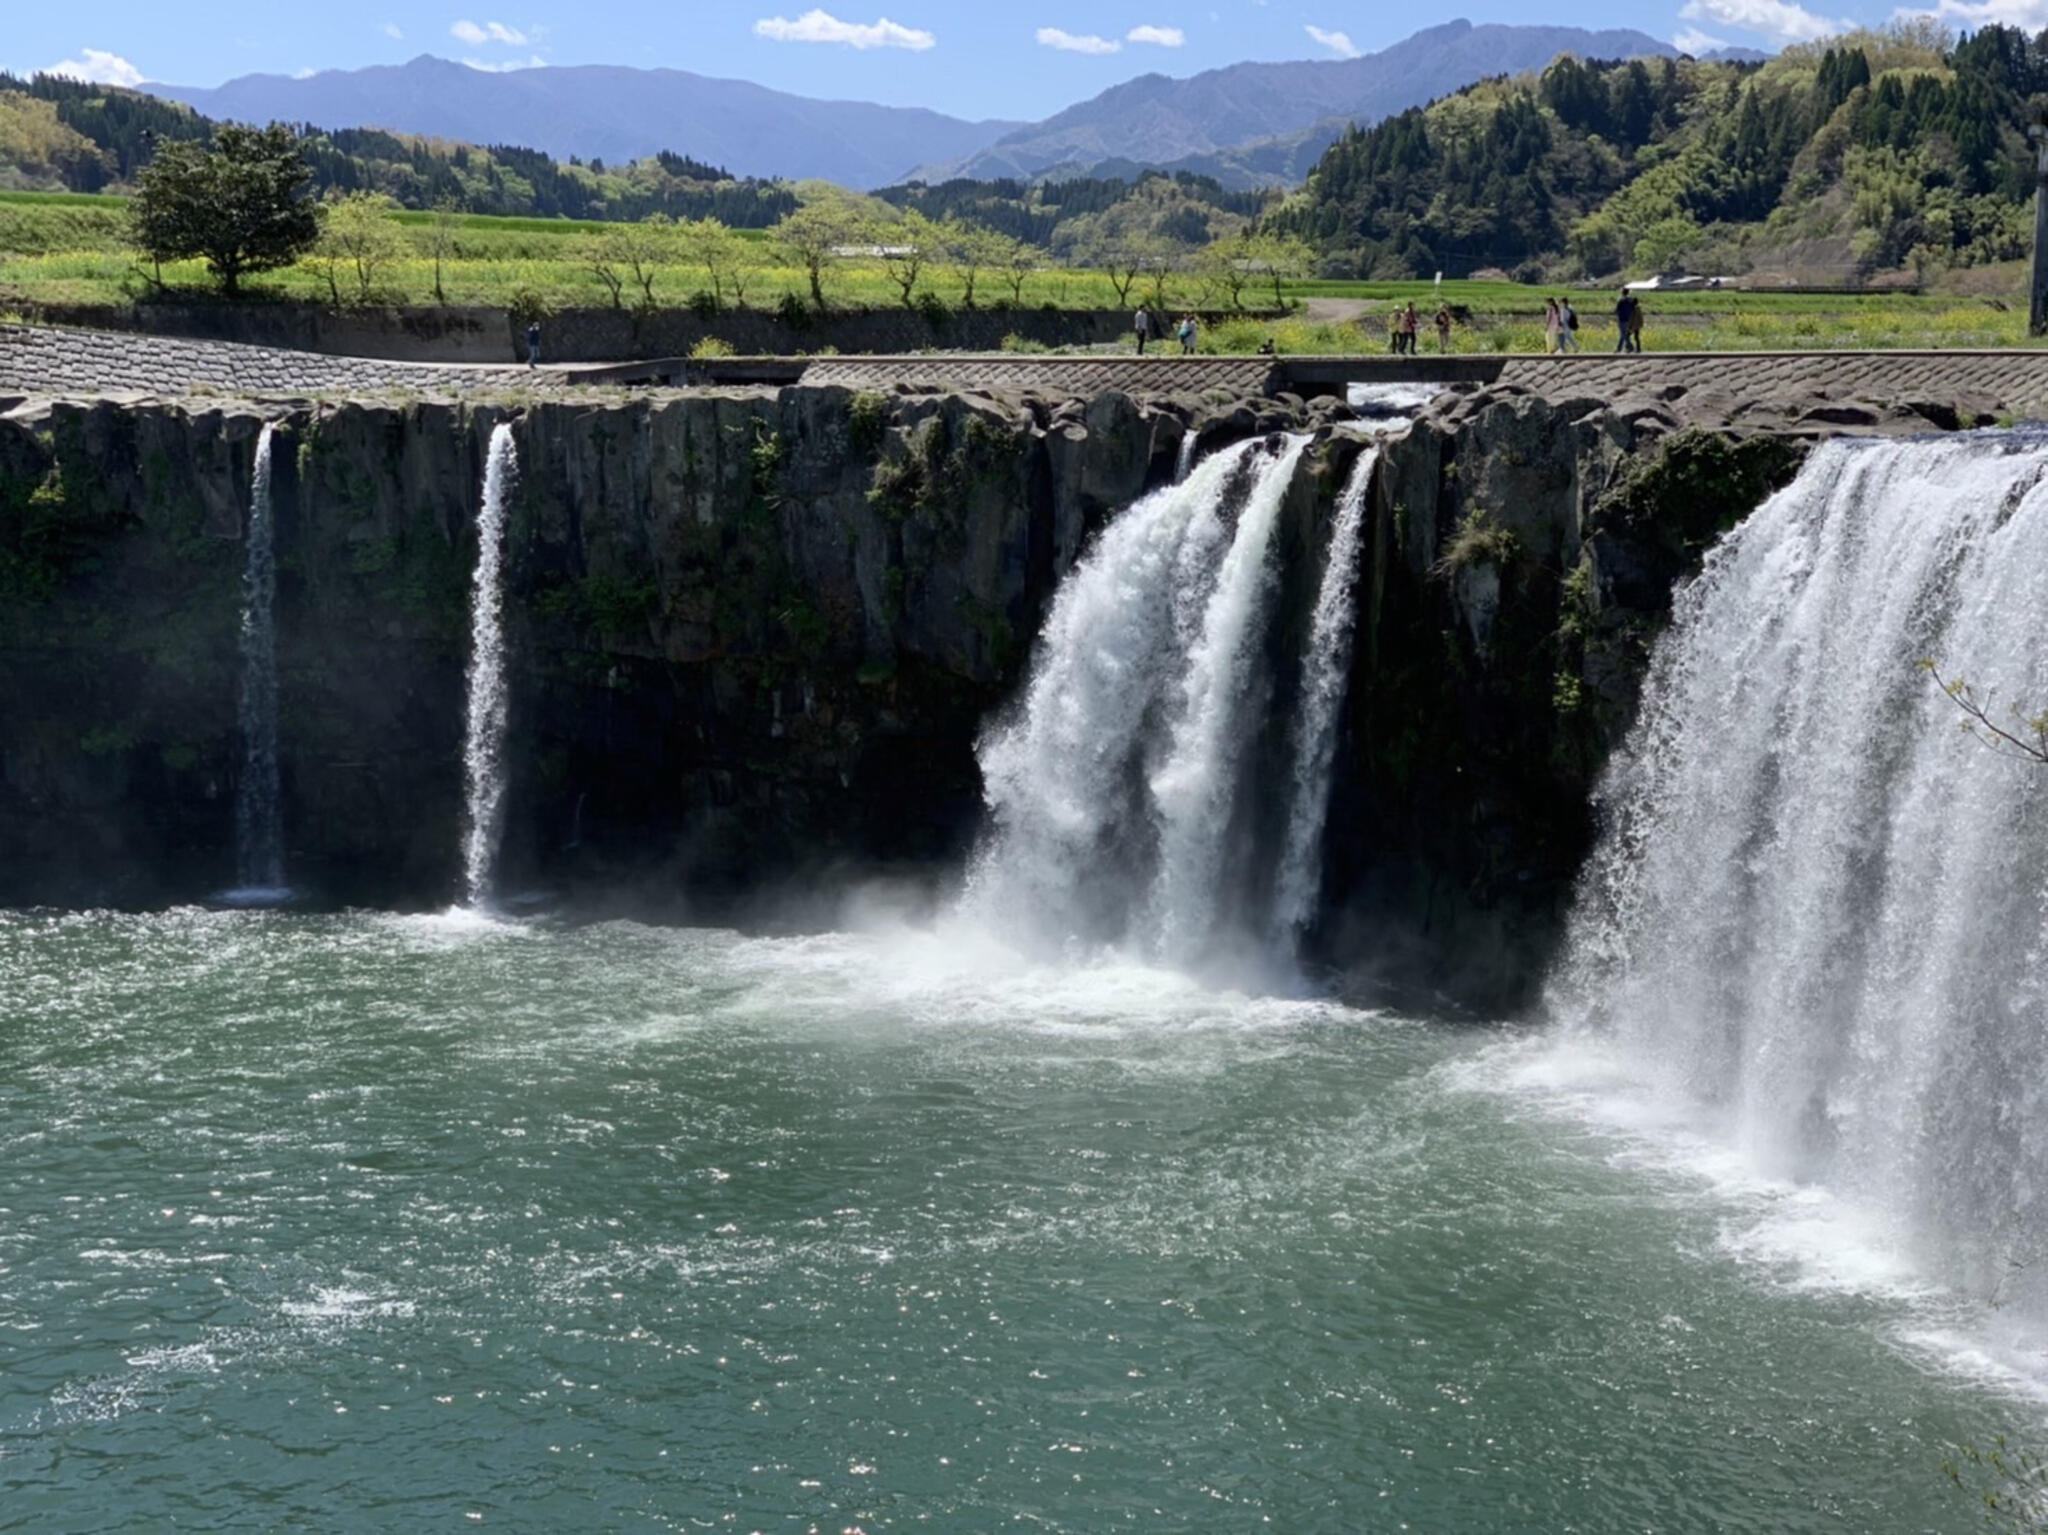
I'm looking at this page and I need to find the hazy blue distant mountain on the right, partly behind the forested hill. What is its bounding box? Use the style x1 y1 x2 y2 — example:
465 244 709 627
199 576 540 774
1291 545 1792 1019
915 20 1677 186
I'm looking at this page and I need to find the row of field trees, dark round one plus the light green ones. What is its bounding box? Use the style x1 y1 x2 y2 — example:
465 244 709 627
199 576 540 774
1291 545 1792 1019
131 125 1311 309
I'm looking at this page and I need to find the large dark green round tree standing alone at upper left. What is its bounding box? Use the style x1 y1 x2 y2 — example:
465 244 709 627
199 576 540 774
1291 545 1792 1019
129 123 319 295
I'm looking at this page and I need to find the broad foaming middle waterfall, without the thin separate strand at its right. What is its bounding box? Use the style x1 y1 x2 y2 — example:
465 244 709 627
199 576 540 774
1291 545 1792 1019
963 438 1309 958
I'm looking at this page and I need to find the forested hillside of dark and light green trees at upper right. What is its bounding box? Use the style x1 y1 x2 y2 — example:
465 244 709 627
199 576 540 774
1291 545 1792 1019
1274 25 2048 278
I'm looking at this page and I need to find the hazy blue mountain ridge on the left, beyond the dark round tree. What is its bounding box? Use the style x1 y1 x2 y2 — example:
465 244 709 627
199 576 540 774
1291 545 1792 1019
145 55 1020 188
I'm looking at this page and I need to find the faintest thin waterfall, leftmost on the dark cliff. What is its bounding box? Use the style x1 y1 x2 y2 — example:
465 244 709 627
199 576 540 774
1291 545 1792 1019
231 424 285 905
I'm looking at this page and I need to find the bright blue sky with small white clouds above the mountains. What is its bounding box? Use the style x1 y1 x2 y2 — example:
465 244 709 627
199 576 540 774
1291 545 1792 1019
0 0 2007 119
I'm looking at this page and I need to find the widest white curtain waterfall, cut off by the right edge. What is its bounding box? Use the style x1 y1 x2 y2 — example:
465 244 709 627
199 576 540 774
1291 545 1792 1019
1550 434 2048 1316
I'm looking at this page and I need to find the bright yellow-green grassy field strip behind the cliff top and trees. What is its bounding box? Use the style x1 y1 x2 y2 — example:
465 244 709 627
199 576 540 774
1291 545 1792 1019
0 192 2028 354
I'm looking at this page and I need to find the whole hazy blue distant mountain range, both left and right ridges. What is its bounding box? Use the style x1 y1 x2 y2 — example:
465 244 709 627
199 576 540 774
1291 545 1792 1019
145 18 1677 188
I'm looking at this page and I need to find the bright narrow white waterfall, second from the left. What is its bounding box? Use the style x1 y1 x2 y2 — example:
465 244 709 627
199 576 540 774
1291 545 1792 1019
463 422 518 909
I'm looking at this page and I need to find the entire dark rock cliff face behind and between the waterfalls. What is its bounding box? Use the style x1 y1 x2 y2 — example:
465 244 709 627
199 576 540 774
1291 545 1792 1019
0 389 1826 1009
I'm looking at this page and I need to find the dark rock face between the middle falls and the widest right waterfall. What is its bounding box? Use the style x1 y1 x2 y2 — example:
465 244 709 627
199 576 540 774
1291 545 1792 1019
1315 393 1806 1009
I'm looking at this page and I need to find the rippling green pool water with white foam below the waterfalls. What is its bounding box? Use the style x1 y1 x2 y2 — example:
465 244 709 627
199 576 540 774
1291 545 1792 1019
0 913 2032 1531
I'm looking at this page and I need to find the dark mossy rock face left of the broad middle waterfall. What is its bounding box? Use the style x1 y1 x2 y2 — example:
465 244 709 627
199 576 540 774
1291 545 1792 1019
0 389 1188 909
